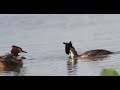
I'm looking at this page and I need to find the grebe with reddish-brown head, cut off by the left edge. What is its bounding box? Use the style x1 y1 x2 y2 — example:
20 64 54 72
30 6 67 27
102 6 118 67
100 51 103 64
0 45 27 68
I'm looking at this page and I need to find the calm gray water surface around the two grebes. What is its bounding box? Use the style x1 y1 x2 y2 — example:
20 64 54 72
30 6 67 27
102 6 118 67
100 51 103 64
0 14 120 76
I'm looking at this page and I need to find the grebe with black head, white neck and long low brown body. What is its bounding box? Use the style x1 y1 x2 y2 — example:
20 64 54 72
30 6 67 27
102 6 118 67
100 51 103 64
63 41 113 59
